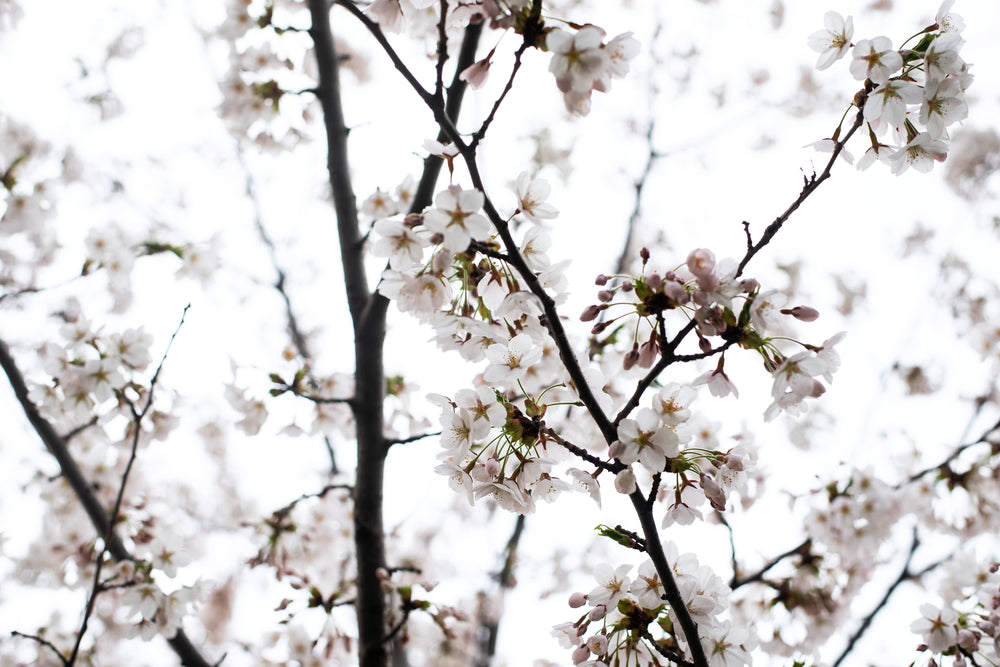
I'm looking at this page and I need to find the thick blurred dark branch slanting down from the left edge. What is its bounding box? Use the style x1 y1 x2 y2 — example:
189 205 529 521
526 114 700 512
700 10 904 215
0 340 210 667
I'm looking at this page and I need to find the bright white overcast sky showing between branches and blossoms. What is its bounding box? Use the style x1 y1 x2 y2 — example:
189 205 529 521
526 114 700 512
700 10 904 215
0 0 1000 665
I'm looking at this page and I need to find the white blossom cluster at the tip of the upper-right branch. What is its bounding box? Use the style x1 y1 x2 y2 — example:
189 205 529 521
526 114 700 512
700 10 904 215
809 0 973 174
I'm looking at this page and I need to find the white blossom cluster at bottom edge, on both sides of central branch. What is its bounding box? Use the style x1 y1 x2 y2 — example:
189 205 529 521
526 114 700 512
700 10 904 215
552 542 757 667
